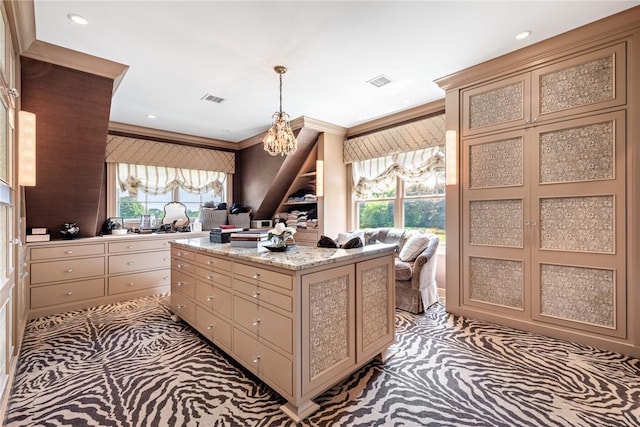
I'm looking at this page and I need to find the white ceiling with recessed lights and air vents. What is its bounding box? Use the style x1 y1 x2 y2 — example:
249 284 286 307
34 0 640 142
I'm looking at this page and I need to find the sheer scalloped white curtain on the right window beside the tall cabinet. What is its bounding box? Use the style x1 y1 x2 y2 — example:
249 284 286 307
353 146 445 198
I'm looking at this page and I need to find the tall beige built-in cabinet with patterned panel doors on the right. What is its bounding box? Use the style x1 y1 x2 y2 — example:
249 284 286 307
438 8 640 355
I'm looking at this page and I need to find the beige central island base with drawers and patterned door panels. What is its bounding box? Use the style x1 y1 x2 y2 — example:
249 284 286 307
171 241 395 422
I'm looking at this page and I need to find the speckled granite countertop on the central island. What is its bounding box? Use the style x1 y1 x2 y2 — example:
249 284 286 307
170 238 395 270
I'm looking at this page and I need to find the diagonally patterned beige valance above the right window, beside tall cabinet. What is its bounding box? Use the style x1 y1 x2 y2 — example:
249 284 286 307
344 114 445 163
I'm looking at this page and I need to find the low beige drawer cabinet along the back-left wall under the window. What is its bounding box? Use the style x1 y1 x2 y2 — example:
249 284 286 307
27 233 205 319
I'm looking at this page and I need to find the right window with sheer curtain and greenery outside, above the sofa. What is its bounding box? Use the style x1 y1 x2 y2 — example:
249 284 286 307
353 147 446 241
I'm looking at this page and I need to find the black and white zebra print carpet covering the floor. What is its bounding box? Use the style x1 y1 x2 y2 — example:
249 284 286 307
5 297 640 427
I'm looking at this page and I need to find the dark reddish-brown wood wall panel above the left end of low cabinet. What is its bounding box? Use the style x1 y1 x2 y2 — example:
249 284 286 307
21 57 113 239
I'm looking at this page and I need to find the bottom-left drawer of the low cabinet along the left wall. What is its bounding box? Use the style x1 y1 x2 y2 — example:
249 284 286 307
31 277 104 309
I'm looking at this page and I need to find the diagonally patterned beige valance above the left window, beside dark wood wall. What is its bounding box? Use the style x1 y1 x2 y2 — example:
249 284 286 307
105 135 236 173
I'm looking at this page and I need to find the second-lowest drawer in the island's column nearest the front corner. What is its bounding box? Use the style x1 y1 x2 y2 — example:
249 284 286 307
233 296 293 354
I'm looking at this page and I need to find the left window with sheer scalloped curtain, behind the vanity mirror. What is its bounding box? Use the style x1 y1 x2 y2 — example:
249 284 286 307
114 163 226 220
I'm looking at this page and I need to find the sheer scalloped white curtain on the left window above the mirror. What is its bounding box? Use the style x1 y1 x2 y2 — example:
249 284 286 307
117 163 226 197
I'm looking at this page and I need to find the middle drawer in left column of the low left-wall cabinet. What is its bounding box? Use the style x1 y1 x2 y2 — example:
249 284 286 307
31 257 104 284
